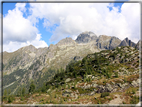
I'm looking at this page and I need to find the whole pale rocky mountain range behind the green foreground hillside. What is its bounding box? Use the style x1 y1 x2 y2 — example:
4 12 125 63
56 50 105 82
3 32 139 97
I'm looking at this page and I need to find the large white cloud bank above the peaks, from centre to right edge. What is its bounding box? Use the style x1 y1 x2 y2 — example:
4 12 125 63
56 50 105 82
30 3 140 42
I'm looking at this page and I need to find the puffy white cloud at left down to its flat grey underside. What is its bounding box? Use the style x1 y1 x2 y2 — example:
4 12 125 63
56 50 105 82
3 3 38 43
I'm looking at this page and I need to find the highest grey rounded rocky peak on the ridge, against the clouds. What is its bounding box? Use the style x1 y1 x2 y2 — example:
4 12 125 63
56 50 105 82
75 31 97 43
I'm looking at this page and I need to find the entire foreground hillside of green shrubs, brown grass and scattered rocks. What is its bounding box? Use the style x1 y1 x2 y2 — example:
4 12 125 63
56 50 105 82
3 45 140 105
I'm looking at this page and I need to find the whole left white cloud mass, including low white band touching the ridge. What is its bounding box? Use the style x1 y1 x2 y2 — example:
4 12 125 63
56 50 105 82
3 3 48 52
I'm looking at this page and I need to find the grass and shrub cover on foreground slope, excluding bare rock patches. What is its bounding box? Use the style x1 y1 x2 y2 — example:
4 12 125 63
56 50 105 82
2 47 139 104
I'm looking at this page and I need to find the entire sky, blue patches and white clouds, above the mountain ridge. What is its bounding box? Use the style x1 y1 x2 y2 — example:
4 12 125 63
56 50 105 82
3 0 140 52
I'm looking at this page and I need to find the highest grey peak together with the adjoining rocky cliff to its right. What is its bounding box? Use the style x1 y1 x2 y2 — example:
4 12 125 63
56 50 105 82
75 32 123 50
